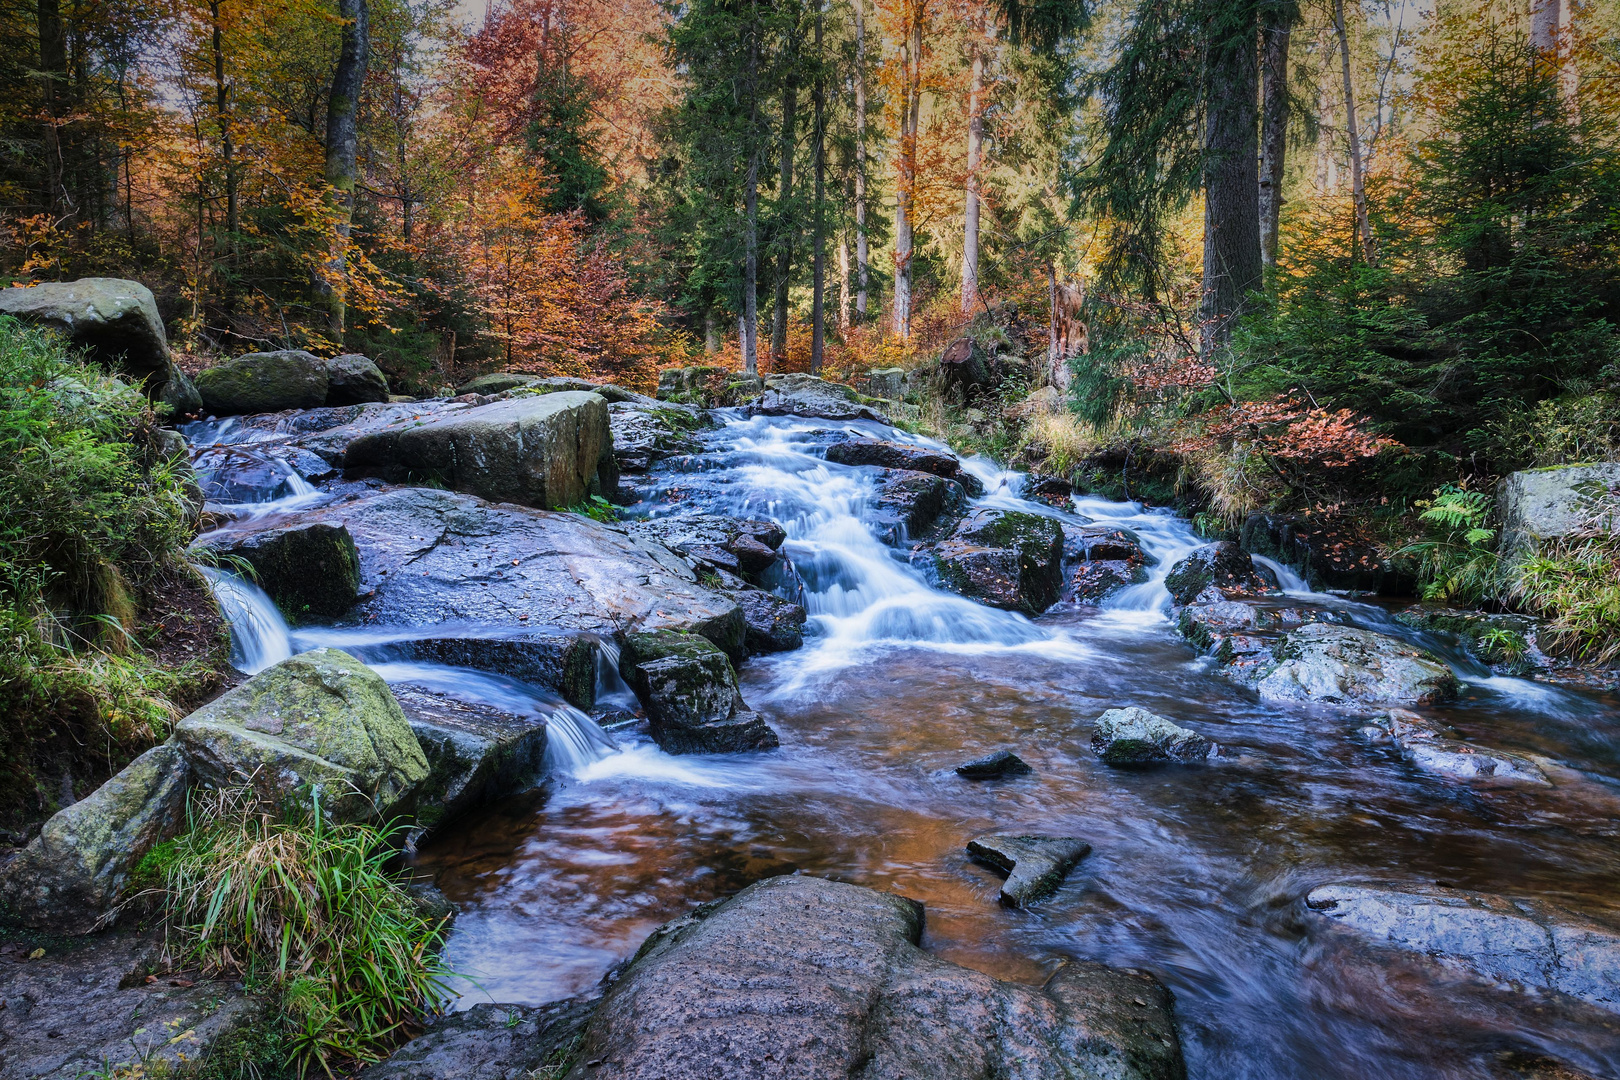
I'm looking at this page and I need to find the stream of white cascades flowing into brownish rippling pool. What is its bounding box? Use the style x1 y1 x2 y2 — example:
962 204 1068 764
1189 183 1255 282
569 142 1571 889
186 413 1620 1080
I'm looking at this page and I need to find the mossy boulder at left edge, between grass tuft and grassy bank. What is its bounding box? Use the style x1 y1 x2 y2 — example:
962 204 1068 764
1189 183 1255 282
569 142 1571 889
0 743 191 934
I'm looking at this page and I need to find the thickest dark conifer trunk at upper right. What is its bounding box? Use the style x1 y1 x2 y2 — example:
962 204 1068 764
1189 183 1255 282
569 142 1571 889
1199 3 1260 356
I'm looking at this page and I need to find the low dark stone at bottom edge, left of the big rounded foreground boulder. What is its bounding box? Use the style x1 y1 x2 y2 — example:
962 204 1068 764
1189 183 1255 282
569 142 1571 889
360 997 599 1080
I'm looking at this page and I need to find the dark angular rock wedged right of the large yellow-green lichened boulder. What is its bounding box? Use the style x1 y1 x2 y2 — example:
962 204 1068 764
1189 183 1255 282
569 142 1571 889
395 687 546 827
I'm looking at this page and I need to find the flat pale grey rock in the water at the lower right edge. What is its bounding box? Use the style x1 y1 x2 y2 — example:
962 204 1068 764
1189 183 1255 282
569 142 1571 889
1306 884 1620 1012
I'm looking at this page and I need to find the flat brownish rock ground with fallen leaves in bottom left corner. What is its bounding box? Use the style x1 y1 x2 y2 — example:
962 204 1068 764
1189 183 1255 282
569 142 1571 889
0 931 264 1080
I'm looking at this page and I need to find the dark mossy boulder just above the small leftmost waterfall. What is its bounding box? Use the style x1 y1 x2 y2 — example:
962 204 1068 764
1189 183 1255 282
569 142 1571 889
201 521 360 622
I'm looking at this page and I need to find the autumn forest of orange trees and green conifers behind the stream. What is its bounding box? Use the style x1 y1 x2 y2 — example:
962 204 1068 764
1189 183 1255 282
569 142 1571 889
0 0 1620 537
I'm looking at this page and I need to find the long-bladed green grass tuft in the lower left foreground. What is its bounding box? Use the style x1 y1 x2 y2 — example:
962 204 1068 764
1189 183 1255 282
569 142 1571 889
162 792 447 1075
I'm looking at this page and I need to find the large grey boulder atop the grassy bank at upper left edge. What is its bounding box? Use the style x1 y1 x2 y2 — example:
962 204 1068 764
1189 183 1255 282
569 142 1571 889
0 277 170 383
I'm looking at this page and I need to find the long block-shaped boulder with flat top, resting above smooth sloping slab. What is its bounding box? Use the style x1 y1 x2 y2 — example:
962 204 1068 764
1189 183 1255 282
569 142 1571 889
343 390 616 508
